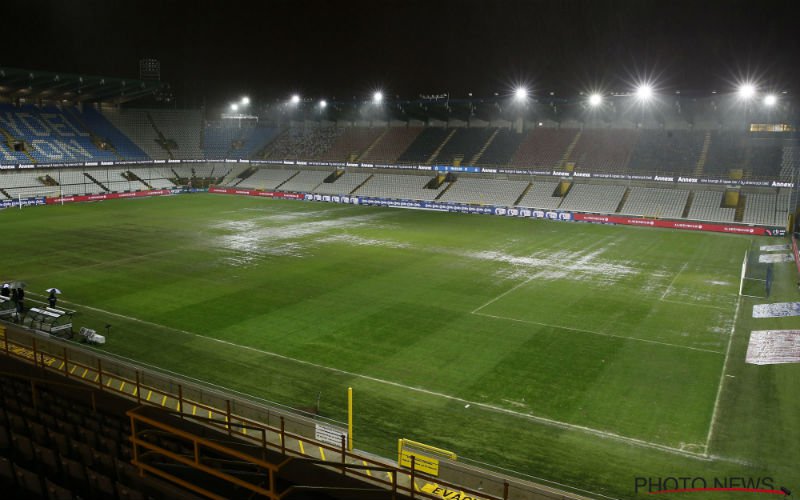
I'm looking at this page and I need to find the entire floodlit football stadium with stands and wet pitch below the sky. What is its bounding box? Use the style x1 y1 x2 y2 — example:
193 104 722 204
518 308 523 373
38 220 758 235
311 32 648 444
0 1 800 500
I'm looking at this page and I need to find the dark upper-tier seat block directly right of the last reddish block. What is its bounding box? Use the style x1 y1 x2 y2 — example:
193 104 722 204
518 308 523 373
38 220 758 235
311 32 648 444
628 130 705 174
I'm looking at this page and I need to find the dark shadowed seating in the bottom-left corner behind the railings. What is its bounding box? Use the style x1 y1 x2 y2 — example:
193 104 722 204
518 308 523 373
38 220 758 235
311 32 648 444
0 368 203 500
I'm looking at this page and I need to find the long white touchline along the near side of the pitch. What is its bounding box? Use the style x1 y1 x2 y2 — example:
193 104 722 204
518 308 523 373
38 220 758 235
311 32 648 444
42 294 709 460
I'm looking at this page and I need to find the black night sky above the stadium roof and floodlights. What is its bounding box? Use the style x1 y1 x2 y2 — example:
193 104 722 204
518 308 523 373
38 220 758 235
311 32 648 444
6 0 800 105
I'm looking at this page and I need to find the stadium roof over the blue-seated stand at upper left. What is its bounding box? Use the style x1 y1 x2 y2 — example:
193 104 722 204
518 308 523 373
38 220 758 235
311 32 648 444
0 67 164 104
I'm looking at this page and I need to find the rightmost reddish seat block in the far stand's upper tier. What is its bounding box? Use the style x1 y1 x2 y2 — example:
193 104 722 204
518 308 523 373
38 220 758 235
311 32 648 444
567 129 636 172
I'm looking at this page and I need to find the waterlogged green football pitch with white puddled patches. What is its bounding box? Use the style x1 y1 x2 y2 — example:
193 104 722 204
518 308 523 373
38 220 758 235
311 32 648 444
0 194 800 498
